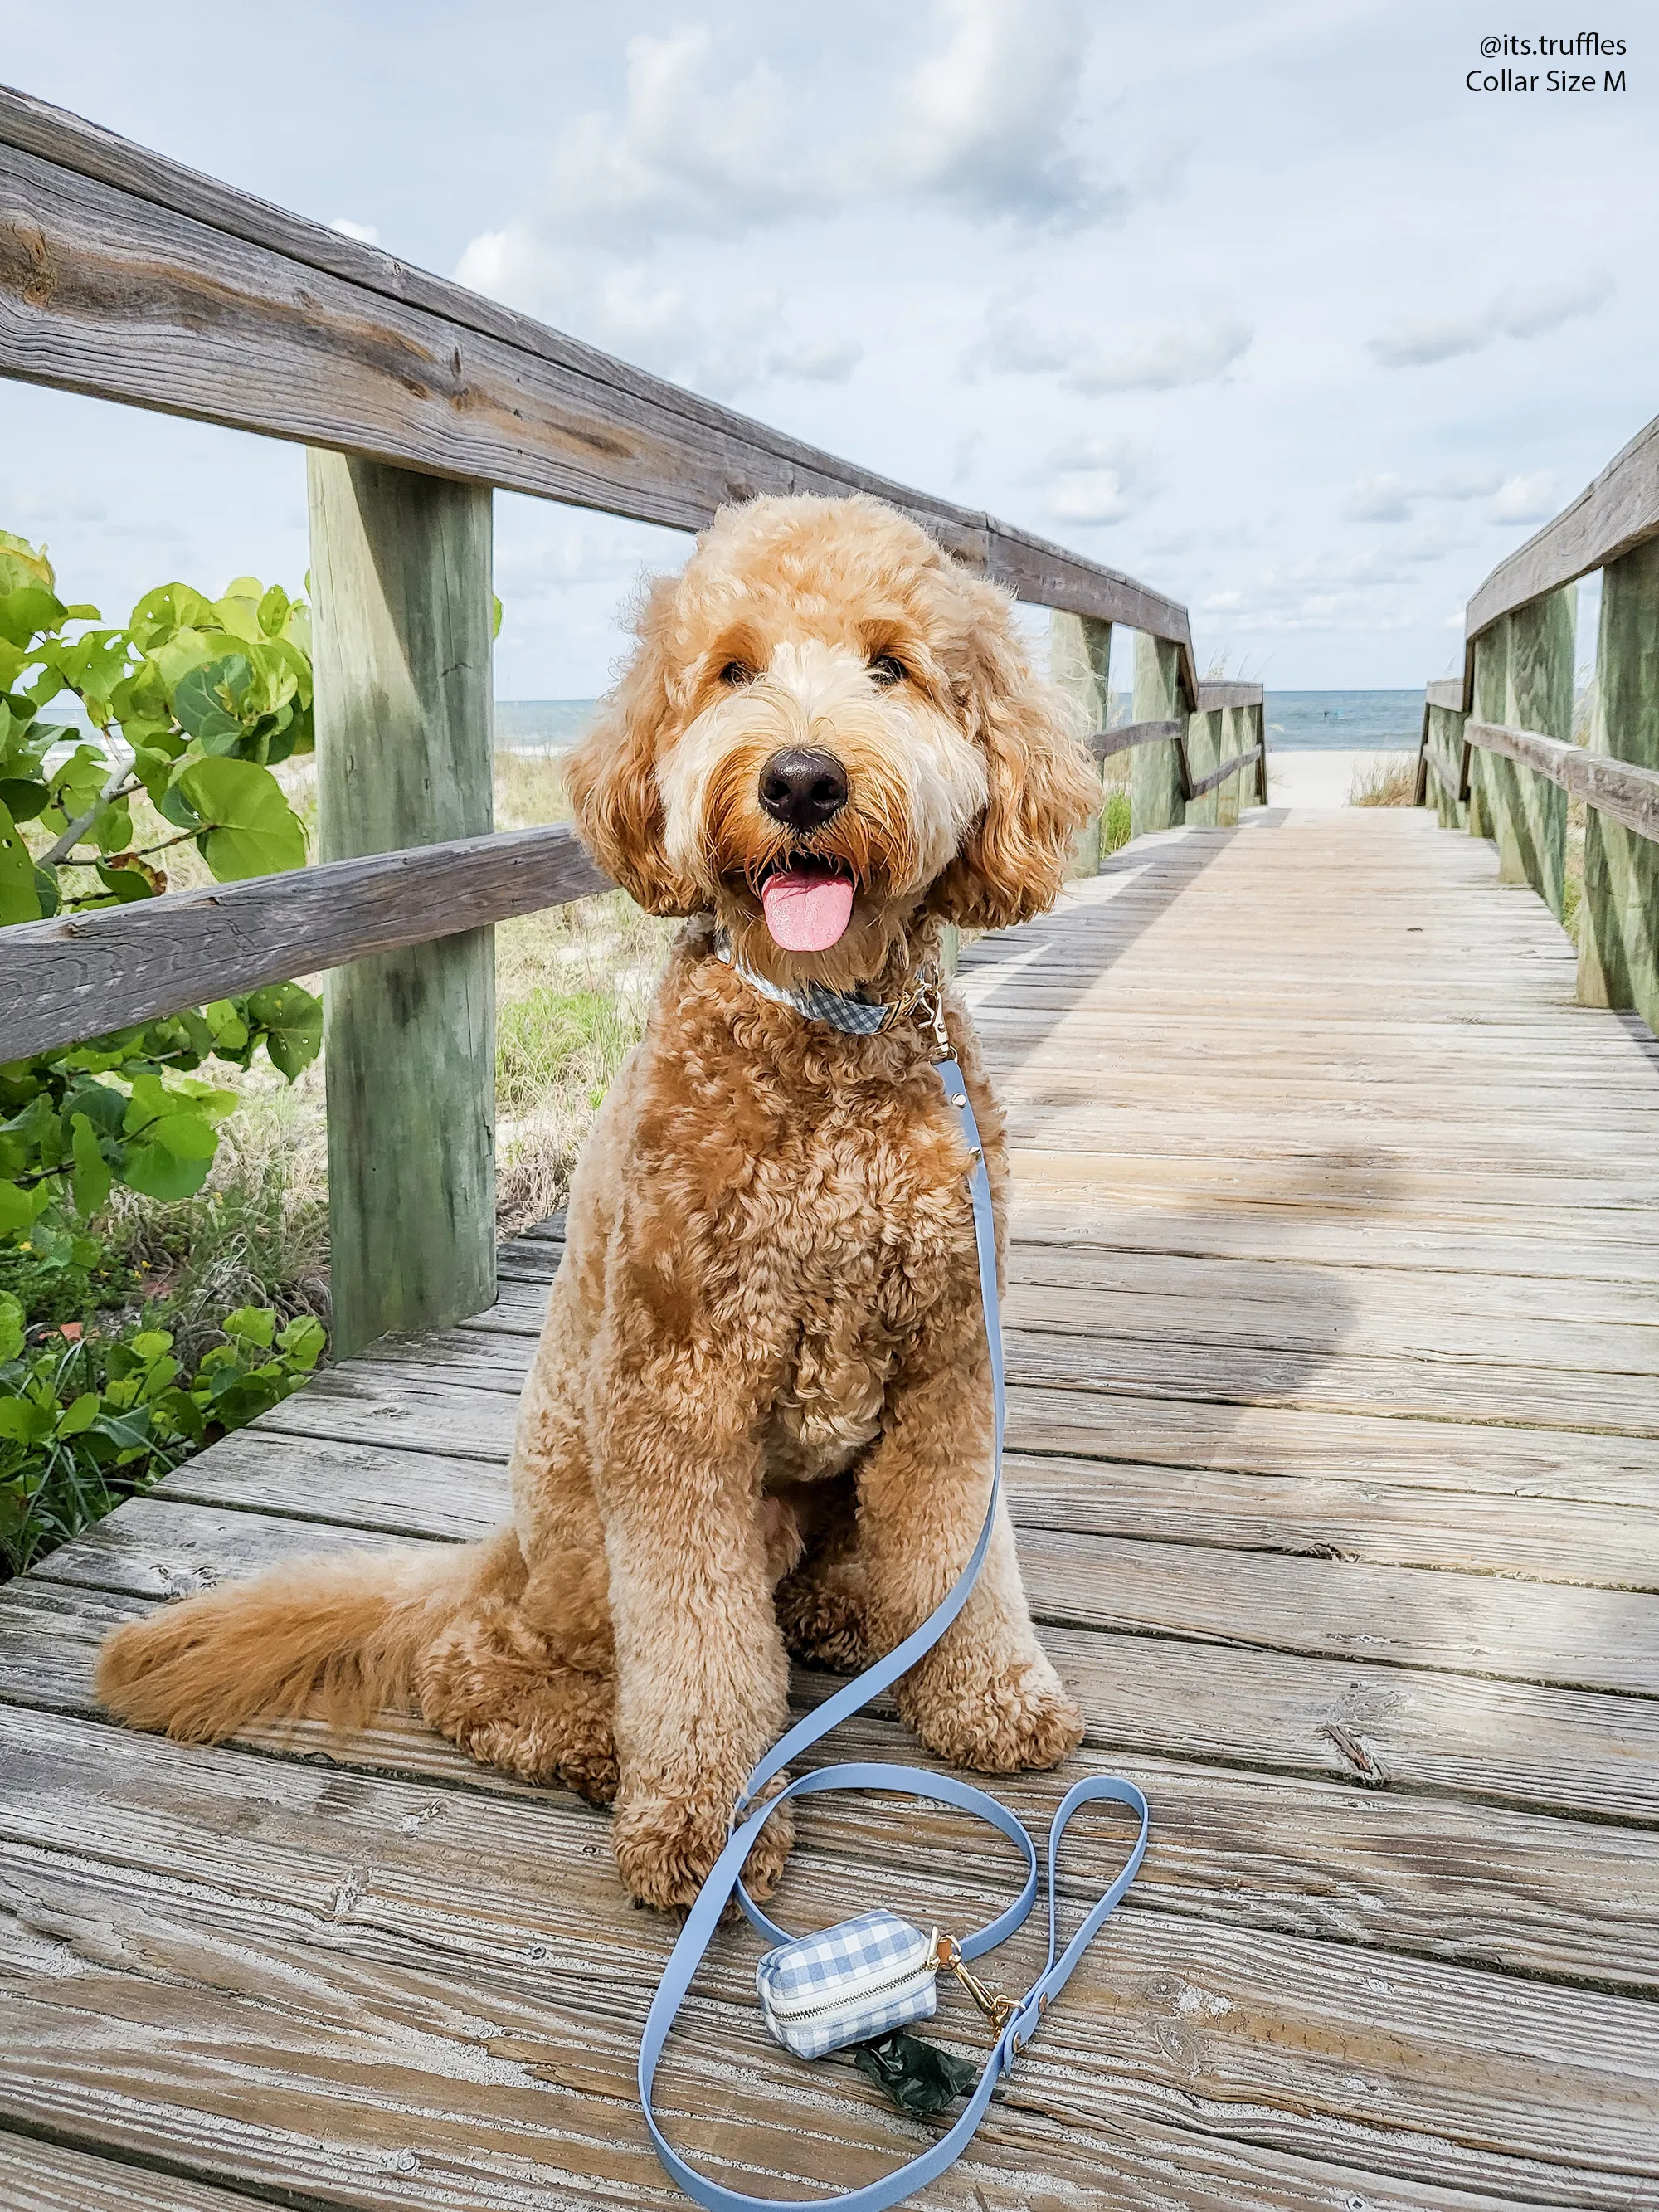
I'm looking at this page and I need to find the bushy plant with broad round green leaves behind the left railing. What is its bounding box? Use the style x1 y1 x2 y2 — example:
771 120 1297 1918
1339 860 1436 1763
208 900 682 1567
0 531 323 1265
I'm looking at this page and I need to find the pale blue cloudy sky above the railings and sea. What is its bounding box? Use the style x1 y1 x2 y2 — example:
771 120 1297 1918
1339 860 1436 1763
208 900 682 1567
0 0 1659 697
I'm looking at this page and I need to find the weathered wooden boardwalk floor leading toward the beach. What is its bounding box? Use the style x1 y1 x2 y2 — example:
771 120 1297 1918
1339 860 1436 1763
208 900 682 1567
0 811 1659 2212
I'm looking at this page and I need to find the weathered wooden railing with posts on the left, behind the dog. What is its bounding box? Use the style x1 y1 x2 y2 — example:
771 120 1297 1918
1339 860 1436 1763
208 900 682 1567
0 89 1265 1352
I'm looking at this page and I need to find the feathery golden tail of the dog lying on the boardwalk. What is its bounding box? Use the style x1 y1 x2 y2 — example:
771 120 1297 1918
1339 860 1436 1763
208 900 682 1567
95 1528 524 1743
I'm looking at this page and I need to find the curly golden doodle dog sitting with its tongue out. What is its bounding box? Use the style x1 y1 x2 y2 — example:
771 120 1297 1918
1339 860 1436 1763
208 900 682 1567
97 498 1099 1907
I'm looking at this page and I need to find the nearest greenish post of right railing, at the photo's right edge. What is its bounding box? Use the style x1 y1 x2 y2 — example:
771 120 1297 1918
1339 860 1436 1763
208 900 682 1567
1579 538 1659 1029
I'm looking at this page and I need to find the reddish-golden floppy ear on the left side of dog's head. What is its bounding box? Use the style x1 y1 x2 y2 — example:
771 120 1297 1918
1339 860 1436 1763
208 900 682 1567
564 575 703 914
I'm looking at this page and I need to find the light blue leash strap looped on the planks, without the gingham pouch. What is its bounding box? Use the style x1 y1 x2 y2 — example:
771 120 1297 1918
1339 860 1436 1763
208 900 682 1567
640 1022 1148 2212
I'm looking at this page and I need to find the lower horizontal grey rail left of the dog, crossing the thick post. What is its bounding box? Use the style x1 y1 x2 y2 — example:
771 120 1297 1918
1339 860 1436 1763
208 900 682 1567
0 823 613 1057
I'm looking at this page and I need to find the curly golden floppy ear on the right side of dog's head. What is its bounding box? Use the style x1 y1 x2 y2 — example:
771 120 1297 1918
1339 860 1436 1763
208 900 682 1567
927 579 1102 929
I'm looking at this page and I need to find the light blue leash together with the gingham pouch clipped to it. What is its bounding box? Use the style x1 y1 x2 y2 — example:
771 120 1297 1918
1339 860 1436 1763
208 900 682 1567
640 1024 1146 2212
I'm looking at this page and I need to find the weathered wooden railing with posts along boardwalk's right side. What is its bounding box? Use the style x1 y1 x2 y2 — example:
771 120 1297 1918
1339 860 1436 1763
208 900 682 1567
1416 421 1659 1029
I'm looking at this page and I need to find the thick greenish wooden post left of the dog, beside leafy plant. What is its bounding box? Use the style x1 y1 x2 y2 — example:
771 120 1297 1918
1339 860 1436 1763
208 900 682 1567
308 451 495 1354
